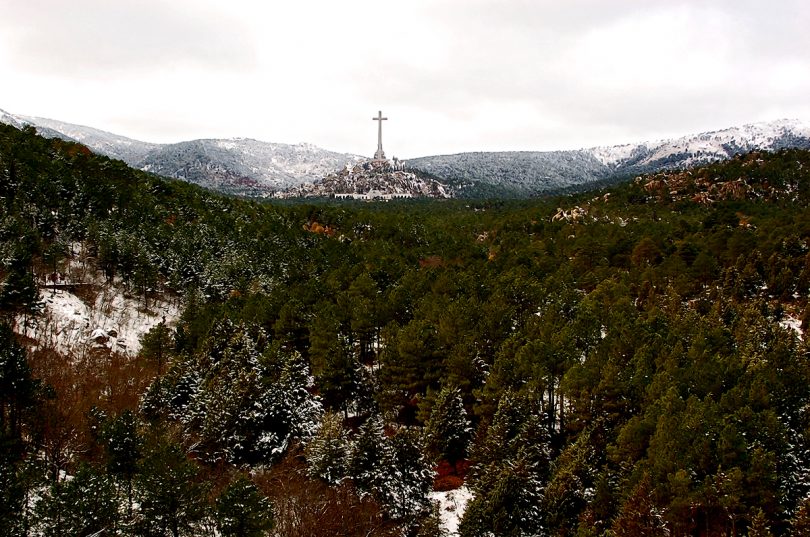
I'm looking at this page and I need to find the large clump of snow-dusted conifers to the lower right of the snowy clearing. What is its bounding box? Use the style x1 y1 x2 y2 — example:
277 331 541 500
147 319 322 463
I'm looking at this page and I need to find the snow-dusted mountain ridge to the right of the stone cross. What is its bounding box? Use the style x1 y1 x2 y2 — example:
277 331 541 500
409 120 810 197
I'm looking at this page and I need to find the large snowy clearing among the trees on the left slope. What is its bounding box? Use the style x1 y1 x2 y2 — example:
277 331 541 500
24 287 181 356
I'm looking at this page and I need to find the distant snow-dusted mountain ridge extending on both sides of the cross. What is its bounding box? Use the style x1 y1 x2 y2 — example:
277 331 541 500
0 110 810 197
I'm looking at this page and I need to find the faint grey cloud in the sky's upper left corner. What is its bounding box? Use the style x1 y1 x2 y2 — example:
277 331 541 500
0 0 253 79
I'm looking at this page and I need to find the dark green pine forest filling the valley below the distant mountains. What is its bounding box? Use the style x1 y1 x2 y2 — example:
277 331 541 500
0 122 810 537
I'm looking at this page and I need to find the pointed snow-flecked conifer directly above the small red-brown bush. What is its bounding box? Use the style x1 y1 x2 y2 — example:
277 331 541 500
425 386 472 468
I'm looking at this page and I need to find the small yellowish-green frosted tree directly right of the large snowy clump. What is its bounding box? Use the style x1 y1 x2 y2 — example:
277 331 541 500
304 412 350 485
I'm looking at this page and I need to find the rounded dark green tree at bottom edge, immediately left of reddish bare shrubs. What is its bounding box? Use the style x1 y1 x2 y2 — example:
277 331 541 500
215 475 274 537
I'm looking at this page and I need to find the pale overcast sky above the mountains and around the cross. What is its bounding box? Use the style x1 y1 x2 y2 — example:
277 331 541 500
0 0 810 158
